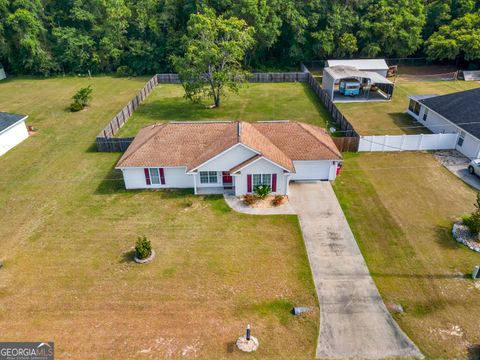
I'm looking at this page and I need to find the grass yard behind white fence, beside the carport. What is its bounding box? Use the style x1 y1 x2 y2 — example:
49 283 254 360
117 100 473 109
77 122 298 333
337 77 480 135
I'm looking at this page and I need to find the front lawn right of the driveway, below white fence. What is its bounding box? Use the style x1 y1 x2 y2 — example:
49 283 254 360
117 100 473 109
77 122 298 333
334 152 480 359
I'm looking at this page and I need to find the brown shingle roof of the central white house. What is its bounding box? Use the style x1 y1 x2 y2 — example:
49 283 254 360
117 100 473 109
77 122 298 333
117 121 342 172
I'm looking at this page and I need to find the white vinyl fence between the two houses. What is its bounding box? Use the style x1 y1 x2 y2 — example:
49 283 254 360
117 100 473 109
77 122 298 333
358 134 458 151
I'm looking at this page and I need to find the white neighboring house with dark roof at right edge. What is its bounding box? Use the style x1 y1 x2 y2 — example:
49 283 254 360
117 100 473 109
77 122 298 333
407 88 480 159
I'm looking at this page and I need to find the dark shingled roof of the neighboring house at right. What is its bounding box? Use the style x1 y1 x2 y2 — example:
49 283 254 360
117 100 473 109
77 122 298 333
420 88 480 139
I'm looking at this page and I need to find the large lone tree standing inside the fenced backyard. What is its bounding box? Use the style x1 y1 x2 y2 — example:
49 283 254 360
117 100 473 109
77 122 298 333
172 8 254 107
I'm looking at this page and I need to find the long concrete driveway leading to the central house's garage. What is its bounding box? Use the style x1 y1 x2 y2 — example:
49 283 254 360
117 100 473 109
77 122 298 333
289 182 423 359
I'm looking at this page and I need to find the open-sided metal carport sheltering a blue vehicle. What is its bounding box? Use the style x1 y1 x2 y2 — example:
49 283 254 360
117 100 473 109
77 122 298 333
322 65 394 102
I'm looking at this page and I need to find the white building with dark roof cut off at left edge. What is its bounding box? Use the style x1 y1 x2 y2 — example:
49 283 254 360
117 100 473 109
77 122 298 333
0 112 28 156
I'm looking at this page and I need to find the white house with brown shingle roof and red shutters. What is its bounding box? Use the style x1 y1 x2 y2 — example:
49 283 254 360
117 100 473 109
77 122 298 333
116 121 342 196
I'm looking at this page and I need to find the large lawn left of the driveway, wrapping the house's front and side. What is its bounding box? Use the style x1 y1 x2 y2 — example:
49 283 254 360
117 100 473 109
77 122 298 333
0 77 318 359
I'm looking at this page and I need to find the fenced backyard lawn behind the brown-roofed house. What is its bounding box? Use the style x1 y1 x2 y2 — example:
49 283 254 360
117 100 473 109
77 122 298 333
118 83 330 136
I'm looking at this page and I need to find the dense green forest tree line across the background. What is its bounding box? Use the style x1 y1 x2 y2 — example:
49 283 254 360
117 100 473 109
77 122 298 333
0 0 480 75
